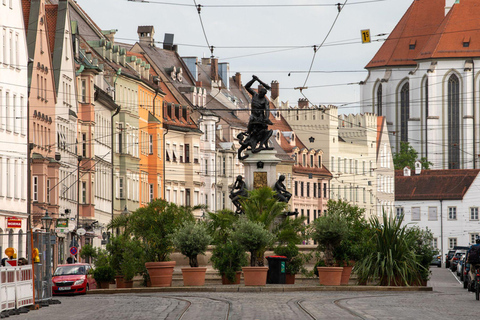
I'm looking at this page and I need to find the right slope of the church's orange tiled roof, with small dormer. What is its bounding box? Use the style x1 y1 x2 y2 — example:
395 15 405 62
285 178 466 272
417 0 480 59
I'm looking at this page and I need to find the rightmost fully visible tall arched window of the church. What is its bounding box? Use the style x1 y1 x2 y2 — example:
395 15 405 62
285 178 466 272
448 74 460 169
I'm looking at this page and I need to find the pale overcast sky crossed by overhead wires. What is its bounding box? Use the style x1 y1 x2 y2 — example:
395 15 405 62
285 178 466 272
77 0 413 114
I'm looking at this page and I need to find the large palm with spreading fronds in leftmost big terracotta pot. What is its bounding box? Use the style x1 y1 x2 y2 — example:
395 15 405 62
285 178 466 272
111 199 194 287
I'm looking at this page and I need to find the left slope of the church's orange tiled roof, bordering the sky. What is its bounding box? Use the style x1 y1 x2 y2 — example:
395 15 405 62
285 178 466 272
365 0 444 68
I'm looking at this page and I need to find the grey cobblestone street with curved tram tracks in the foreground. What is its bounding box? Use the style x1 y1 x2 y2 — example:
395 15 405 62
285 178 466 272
10 268 480 320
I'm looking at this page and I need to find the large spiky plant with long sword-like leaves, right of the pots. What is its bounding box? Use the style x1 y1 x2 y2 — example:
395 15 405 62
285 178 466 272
355 213 423 286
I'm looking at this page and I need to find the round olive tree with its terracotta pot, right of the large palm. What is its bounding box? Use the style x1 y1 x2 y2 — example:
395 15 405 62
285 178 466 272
173 221 212 286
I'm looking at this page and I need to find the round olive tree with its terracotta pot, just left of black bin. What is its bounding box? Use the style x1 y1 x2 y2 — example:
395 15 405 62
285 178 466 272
232 218 274 286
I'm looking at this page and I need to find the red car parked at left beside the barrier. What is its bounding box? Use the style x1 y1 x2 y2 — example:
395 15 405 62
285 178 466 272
52 263 97 295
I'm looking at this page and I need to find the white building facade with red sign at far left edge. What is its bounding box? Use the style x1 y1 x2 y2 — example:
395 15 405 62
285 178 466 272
0 0 30 258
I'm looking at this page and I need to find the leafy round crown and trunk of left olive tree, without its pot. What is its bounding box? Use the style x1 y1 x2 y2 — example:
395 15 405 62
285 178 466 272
173 221 212 268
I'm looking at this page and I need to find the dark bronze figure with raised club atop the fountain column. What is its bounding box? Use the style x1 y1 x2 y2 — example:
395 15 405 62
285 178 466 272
237 75 273 160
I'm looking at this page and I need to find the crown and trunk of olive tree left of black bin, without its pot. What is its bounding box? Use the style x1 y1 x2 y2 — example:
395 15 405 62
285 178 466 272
232 218 274 267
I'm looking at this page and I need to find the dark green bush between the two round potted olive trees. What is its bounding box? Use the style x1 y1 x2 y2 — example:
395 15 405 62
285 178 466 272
210 241 248 284
